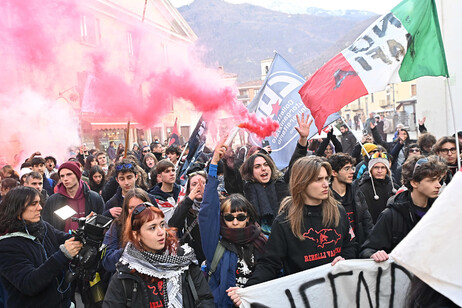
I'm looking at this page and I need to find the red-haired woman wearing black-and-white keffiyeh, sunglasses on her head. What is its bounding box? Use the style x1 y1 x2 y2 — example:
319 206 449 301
103 202 214 308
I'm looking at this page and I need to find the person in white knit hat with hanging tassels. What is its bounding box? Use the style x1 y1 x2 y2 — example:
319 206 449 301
358 152 396 224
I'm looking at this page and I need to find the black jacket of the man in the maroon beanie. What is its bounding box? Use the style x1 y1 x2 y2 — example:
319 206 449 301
42 184 104 231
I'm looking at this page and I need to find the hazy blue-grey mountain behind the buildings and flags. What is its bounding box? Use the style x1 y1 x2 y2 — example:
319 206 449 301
178 0 377 82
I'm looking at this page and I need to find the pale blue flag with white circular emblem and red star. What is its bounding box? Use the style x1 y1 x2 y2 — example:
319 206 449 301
247 53 340 169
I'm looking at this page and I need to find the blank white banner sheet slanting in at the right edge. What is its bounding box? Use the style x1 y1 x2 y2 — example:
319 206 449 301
390 171 462 306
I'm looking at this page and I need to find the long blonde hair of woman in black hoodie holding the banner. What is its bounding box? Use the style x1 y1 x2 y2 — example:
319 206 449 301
279 156 340 240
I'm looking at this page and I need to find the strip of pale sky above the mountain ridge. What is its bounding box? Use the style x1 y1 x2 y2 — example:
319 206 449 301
170 0 400 14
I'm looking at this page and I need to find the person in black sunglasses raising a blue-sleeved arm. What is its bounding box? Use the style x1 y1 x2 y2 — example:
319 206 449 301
199 143 266 307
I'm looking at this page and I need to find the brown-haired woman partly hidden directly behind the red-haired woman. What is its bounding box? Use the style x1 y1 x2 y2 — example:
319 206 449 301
102 188 151 273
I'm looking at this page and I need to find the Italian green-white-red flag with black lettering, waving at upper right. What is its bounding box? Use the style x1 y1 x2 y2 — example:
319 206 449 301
299 0 449 132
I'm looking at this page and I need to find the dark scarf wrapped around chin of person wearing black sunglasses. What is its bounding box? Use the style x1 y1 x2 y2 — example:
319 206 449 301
220 222 266 266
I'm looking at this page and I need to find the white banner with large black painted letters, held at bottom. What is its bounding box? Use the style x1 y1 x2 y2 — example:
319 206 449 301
237 259 412 308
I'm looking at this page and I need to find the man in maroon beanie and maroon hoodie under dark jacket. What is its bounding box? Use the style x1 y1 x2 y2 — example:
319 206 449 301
42 161 104 232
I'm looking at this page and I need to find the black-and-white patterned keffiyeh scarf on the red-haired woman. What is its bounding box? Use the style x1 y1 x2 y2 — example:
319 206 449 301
120 242 197 308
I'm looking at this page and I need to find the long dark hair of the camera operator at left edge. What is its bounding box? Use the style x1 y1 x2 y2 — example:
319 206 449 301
0 186 40 234
